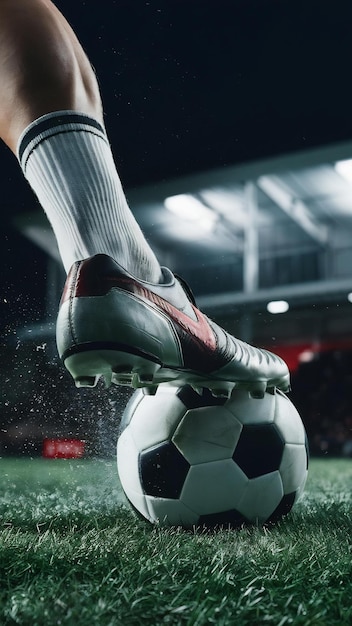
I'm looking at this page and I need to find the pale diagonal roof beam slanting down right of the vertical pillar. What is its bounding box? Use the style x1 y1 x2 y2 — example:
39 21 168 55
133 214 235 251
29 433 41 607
257 176 328 246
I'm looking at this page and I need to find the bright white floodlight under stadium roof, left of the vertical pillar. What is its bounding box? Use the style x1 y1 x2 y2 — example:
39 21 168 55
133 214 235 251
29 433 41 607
164 193 217 232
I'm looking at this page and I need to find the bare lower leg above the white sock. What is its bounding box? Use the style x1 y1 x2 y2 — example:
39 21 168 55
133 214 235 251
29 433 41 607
0 0 103 152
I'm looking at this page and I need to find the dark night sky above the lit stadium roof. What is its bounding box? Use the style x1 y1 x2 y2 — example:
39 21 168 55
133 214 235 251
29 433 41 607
0 0 352 330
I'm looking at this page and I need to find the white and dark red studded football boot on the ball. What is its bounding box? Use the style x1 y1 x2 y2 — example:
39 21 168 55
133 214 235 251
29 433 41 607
57 254 290 398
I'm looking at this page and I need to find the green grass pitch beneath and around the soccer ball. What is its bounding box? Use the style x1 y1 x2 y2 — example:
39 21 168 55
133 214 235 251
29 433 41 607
0 459 352 626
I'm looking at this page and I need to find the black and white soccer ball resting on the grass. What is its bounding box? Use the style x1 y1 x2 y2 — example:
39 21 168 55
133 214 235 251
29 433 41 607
117 385 308 529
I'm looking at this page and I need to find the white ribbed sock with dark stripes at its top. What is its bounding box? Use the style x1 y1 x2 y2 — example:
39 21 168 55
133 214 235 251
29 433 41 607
17 111 161 282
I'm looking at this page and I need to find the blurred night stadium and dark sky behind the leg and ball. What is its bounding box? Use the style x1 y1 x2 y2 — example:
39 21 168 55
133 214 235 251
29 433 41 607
0 0 352 456
